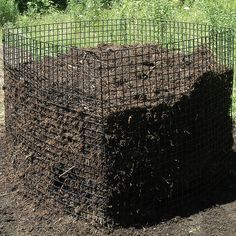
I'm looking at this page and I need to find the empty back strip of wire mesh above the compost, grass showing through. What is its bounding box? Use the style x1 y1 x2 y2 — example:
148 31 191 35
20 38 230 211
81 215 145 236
2 19 235 61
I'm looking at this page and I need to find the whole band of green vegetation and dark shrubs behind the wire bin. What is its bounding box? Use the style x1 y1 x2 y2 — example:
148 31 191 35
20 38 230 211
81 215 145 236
0 0 236 114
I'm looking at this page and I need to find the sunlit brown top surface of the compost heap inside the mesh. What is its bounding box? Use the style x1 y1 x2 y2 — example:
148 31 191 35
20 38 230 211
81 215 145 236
11 44 227 110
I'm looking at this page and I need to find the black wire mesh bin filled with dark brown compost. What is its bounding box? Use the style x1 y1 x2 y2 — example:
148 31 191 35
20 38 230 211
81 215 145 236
3 19 234 225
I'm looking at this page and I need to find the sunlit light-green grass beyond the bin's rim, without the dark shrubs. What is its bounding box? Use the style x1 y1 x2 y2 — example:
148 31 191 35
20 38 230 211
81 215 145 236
13 0 236 28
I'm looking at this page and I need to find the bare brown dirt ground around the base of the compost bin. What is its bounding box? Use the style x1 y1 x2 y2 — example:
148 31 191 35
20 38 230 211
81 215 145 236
0 49 236 236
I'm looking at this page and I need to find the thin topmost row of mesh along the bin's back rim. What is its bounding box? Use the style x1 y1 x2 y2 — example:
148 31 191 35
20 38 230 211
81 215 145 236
3 18 235 34
